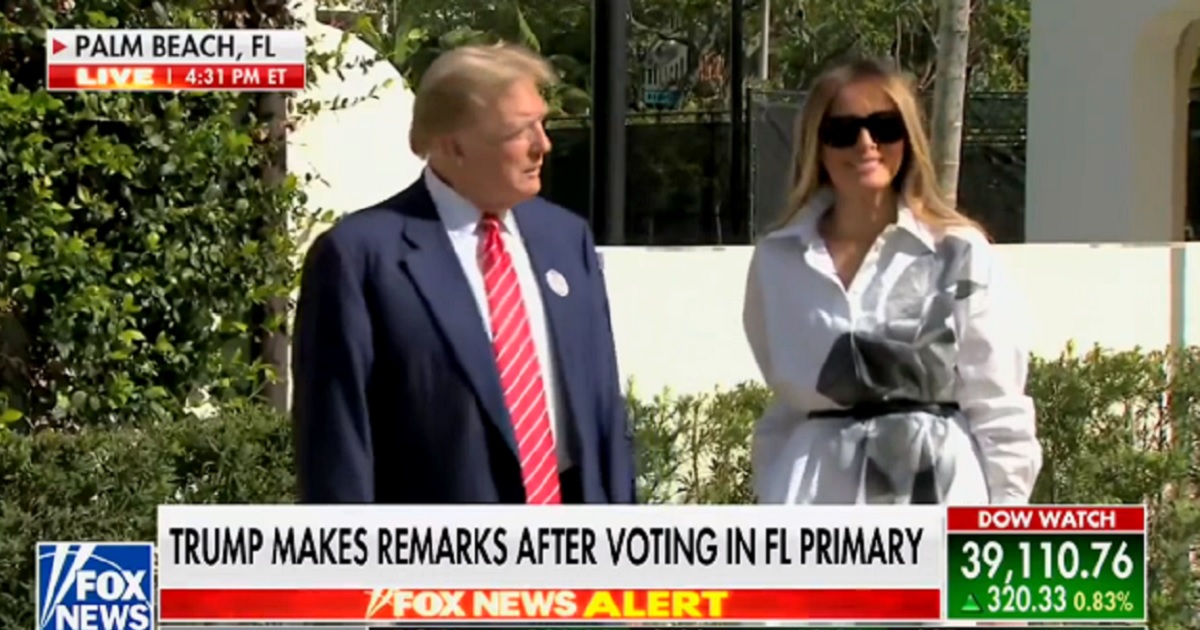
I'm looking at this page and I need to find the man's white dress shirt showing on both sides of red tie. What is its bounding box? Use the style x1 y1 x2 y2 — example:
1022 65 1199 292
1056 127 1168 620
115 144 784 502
424 168 571 470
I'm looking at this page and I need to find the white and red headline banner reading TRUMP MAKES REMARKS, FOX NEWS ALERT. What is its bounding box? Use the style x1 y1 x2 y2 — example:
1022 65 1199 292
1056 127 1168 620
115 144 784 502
158 505 946 624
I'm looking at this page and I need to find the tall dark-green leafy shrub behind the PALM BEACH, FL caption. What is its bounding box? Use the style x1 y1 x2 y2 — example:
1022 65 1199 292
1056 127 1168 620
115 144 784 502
0 0 300 426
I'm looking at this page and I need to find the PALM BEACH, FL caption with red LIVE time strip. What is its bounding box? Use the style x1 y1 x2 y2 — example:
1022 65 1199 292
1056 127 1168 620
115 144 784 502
46 29 307 91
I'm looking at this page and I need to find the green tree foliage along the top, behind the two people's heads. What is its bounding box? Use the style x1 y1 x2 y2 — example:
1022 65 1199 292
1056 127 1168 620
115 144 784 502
338 0 1030 113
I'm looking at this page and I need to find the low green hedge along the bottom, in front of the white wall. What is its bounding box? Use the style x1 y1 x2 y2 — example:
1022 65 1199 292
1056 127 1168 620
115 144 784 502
0 350 1200 630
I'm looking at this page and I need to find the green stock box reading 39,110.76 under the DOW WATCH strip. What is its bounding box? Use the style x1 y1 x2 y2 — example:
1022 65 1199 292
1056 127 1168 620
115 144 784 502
946 533 1146 623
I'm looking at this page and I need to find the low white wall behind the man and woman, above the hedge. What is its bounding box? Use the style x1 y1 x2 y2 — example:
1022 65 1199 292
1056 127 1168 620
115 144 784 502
604 244 1200 395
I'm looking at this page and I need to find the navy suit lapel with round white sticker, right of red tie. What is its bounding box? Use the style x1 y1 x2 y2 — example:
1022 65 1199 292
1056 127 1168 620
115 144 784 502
514 199 594 439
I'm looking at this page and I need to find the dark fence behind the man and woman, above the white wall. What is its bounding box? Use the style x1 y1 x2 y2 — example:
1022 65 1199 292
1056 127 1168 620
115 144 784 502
542 92 1025 246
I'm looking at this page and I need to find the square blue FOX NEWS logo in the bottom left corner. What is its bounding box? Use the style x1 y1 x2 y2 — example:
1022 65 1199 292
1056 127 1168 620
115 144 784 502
37 542 154 630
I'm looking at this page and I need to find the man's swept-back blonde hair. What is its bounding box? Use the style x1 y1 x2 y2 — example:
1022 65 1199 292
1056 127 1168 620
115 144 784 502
408 43 558 157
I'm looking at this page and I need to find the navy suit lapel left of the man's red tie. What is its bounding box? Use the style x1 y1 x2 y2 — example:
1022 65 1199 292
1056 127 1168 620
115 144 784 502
400 184 517 455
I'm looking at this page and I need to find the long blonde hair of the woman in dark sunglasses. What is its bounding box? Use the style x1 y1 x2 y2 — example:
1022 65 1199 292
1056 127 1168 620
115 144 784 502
775 59 986 235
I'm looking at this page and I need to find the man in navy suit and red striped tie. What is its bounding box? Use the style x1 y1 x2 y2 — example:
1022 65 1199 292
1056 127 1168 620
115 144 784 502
293 41 635 504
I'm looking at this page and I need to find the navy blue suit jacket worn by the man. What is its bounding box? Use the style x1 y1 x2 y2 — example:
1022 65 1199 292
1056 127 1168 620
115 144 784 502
293 180 635 504
